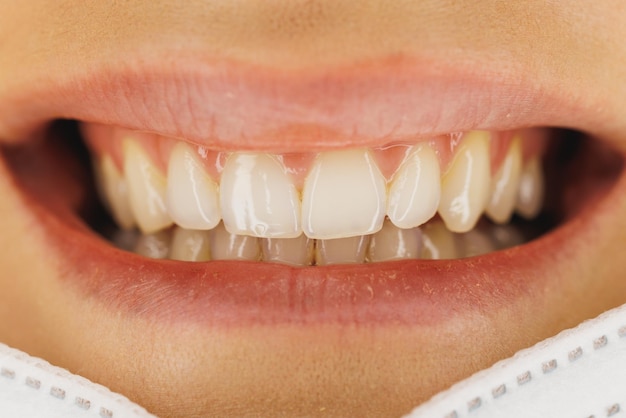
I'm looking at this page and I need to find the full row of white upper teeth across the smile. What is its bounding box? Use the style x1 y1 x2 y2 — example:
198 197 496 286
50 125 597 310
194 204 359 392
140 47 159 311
91 131 543 242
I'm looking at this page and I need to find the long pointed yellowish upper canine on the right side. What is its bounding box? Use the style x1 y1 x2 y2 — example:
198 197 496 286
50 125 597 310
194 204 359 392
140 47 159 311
439 131 490 232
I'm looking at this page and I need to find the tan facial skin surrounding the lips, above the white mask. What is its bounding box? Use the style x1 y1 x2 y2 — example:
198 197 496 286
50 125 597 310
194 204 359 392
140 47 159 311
0 0 626 417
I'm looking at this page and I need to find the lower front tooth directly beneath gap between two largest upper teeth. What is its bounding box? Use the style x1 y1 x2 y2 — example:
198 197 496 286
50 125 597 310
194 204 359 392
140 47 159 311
261 234 315 266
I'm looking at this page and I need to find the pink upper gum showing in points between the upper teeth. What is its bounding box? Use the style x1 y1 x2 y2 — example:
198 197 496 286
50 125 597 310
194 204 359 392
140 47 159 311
81 124 549 188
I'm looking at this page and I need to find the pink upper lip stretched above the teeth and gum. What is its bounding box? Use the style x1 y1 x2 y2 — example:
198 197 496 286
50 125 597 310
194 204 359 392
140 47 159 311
0 51 621 152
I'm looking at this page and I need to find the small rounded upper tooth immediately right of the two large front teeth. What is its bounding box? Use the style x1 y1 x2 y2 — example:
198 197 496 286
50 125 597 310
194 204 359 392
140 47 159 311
387 144 441 229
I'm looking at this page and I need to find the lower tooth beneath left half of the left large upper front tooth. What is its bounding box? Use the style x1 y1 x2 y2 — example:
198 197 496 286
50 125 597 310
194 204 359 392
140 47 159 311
209 222 260 261
